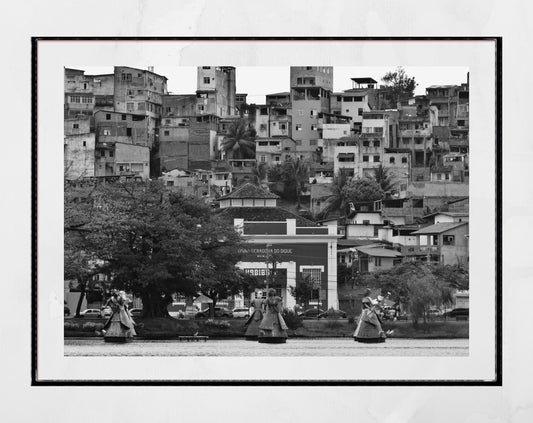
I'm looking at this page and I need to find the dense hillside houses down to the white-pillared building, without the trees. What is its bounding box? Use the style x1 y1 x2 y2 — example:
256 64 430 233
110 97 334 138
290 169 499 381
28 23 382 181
64 66 469 308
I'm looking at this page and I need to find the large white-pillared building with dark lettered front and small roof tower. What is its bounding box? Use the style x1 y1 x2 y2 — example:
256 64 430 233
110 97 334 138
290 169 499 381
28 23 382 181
219 184 339 309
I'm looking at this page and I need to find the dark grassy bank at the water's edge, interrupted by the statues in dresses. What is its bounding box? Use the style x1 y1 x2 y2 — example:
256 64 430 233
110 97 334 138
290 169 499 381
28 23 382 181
65 318 469 339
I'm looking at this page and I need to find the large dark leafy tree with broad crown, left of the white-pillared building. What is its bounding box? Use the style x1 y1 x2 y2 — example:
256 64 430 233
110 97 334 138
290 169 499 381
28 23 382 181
65 182 247 317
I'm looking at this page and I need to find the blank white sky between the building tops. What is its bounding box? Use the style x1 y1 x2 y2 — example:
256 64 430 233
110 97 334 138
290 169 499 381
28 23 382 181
74 64 468 104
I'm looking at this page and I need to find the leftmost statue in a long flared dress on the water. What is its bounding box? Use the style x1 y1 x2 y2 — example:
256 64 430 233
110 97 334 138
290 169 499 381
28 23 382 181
102 291 137 342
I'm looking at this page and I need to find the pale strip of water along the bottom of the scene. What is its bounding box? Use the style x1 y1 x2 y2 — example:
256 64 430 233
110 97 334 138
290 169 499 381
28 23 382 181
64 338 468 357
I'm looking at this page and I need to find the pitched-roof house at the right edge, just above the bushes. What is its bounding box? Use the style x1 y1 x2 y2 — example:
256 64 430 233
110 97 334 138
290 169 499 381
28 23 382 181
411 222 469 265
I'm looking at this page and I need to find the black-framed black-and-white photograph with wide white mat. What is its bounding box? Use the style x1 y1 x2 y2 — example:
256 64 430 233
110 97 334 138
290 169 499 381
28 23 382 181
32 37 502 386
